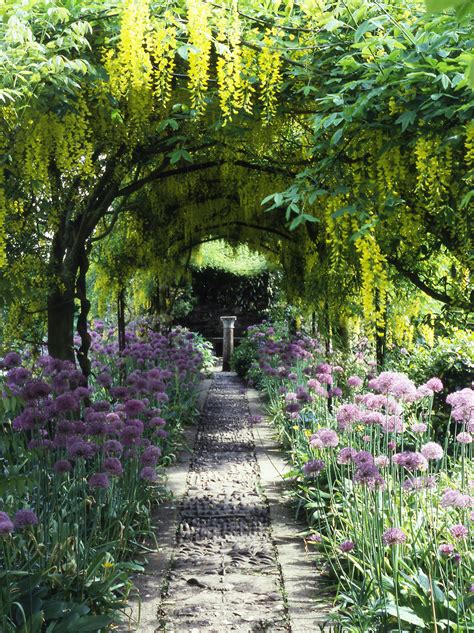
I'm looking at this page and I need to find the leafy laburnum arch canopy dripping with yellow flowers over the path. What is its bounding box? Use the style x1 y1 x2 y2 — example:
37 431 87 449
0 0 474 371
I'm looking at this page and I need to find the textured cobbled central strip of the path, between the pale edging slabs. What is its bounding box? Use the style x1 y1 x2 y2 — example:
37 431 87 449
160 373 290 633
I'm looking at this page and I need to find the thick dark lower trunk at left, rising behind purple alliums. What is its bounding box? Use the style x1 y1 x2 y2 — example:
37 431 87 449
48 280 75 362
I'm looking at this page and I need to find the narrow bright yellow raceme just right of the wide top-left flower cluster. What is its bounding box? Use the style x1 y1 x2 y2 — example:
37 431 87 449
188 0 212 113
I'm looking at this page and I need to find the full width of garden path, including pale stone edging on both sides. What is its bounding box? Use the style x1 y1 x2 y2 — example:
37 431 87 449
120 372 329 633
